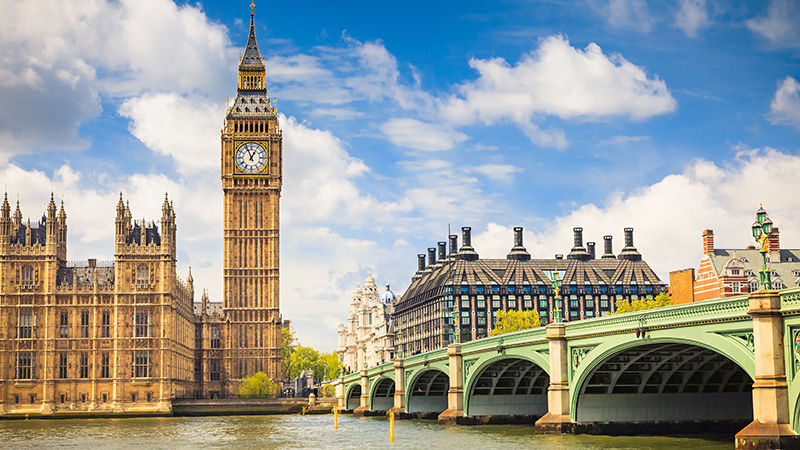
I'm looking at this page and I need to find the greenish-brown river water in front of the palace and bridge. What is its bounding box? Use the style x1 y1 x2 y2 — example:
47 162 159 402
0 414 733 449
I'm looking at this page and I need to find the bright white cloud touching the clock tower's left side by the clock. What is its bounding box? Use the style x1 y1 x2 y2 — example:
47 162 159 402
119 92 225 175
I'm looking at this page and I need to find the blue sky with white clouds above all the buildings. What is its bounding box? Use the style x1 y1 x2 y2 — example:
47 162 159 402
0 0 800 351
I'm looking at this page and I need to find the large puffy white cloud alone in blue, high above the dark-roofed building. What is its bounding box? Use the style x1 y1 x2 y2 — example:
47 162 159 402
441 36 677 147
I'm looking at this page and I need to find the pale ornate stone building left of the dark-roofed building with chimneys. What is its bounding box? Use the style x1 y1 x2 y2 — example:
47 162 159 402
336 275 395 372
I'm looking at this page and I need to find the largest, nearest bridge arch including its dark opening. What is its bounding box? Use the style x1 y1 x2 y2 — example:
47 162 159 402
571 330 755 423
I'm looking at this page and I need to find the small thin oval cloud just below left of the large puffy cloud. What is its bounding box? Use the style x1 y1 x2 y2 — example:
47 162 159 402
380 118 467 152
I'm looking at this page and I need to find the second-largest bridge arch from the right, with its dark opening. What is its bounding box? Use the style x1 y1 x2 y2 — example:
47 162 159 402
464 354 550 417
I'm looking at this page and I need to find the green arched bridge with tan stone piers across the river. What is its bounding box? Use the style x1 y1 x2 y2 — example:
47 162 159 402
337 288 800 448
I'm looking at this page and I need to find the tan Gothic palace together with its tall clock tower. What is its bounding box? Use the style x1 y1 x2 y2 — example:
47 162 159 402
0 8 282 415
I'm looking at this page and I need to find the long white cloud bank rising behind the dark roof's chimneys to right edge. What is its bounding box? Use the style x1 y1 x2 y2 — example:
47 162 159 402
473 149 800 282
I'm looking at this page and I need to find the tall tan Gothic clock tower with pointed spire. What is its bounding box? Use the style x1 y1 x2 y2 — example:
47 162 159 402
221 5 283 384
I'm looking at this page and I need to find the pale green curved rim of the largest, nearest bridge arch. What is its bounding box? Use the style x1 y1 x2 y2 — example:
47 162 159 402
568 329 755 420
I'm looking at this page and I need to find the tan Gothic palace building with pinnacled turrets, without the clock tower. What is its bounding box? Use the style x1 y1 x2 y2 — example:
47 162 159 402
0 196 195 414
